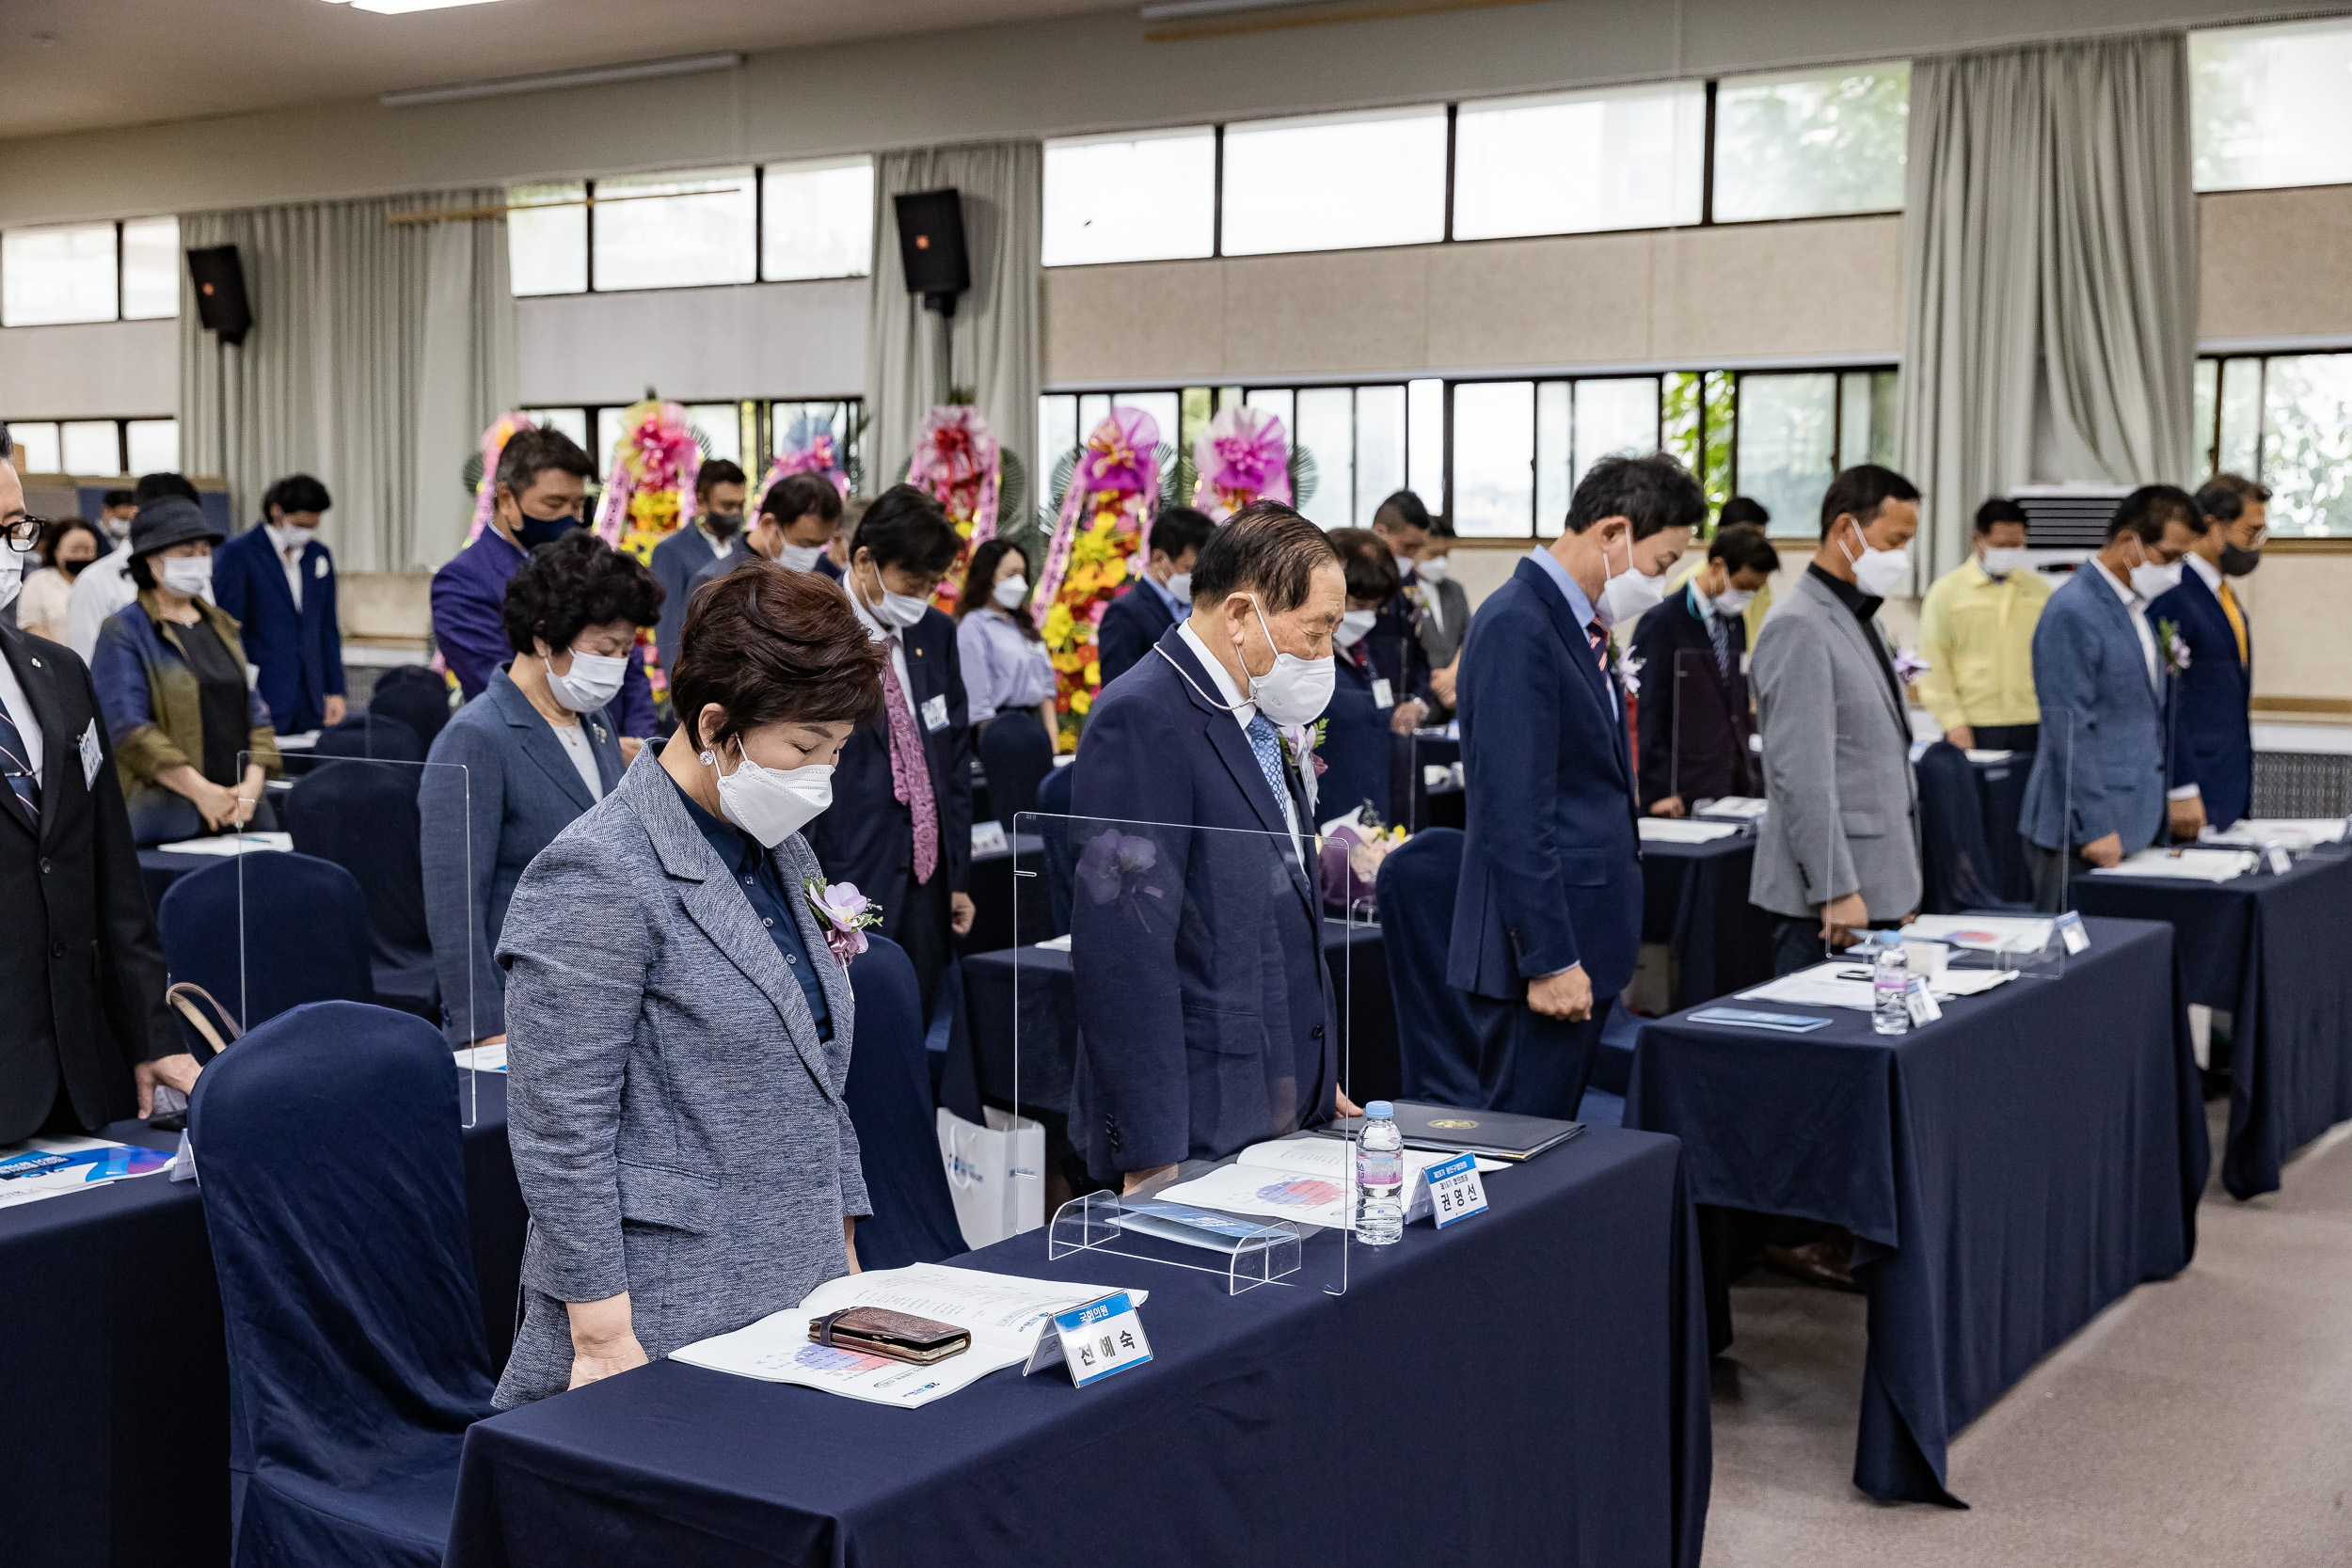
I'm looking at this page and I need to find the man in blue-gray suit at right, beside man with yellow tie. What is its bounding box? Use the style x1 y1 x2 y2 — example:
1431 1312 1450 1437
2018 484 2206 912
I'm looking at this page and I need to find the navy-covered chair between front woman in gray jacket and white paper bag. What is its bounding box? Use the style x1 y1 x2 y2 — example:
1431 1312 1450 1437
845 936 964 1270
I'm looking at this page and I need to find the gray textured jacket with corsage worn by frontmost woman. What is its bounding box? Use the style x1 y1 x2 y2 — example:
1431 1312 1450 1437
497 748 868 1408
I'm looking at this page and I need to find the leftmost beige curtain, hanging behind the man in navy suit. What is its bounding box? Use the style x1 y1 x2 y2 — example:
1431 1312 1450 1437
179 188 516 571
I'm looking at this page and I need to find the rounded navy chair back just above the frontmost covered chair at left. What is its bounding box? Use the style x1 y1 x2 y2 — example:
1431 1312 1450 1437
155 851 376 1030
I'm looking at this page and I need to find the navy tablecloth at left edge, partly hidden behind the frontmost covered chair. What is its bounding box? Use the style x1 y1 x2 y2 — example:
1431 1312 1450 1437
0 1072 525 1568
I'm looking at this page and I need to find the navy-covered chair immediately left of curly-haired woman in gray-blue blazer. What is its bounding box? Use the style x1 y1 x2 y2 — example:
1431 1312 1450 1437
278 759 440 1022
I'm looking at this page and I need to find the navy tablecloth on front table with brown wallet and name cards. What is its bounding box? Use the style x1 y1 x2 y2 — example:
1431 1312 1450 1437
447 1129 1710 1568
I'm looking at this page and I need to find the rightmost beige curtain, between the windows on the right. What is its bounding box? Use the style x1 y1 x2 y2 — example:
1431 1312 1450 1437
1896 33 2197 585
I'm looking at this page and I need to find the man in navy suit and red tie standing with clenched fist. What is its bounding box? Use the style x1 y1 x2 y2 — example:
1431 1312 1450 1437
1447 453 1708 1117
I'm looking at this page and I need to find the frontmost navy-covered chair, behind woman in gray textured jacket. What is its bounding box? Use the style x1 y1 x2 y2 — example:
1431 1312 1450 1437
188 1002 492 1568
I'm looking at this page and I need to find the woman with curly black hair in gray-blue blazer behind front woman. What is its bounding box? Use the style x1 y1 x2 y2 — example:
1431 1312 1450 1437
417 529 661 1049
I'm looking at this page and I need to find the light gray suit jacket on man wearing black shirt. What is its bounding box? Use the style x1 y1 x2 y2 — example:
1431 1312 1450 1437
1748 574 1919 919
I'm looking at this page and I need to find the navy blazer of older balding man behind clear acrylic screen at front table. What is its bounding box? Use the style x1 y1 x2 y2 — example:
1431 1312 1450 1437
1068 630 1339 1180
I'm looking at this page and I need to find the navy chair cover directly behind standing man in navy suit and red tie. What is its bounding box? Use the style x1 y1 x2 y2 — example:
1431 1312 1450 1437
1374 828 1482 1105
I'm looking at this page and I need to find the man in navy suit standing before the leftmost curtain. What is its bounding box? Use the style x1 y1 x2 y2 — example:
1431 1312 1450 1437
212 472 343 736
